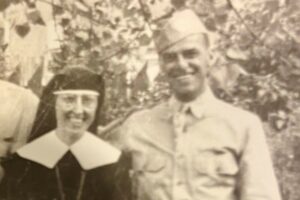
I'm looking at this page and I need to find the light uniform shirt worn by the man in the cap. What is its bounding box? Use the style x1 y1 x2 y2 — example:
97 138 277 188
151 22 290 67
121 90 280 200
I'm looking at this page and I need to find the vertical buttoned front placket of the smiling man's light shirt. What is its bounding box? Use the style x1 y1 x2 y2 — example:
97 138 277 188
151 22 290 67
172 109 190 200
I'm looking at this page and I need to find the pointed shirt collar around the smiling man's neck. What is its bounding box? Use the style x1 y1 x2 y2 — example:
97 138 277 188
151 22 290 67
166 87 216 119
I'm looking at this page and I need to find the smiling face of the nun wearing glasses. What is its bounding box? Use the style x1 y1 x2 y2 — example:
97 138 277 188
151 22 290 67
55 90 98 134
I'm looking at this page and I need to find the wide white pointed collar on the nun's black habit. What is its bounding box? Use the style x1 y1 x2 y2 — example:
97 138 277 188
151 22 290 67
17 131 121 170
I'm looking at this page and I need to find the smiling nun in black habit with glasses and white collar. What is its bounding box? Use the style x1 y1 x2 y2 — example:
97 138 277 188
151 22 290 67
0 67 131 200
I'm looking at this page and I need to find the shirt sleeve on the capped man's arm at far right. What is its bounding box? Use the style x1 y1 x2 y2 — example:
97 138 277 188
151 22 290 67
239 117 281 200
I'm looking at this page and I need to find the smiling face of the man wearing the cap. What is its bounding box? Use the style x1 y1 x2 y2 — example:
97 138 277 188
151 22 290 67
160 35 209 101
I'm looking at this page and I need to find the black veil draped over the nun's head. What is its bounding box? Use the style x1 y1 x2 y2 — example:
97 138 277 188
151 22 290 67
29 67 105 141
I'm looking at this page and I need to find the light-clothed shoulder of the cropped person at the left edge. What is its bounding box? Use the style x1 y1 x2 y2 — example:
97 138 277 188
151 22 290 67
0 81 38 157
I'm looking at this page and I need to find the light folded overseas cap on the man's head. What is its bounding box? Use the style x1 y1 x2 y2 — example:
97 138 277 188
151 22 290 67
154 9 209 52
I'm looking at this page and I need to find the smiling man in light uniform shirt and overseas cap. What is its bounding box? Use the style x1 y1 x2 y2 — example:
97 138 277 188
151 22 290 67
122 10 280 200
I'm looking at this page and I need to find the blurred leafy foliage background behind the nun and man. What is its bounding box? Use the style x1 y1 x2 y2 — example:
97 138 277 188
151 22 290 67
0 0 300 200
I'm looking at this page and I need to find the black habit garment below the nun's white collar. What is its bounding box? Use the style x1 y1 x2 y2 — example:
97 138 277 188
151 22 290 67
0 132 131 200
